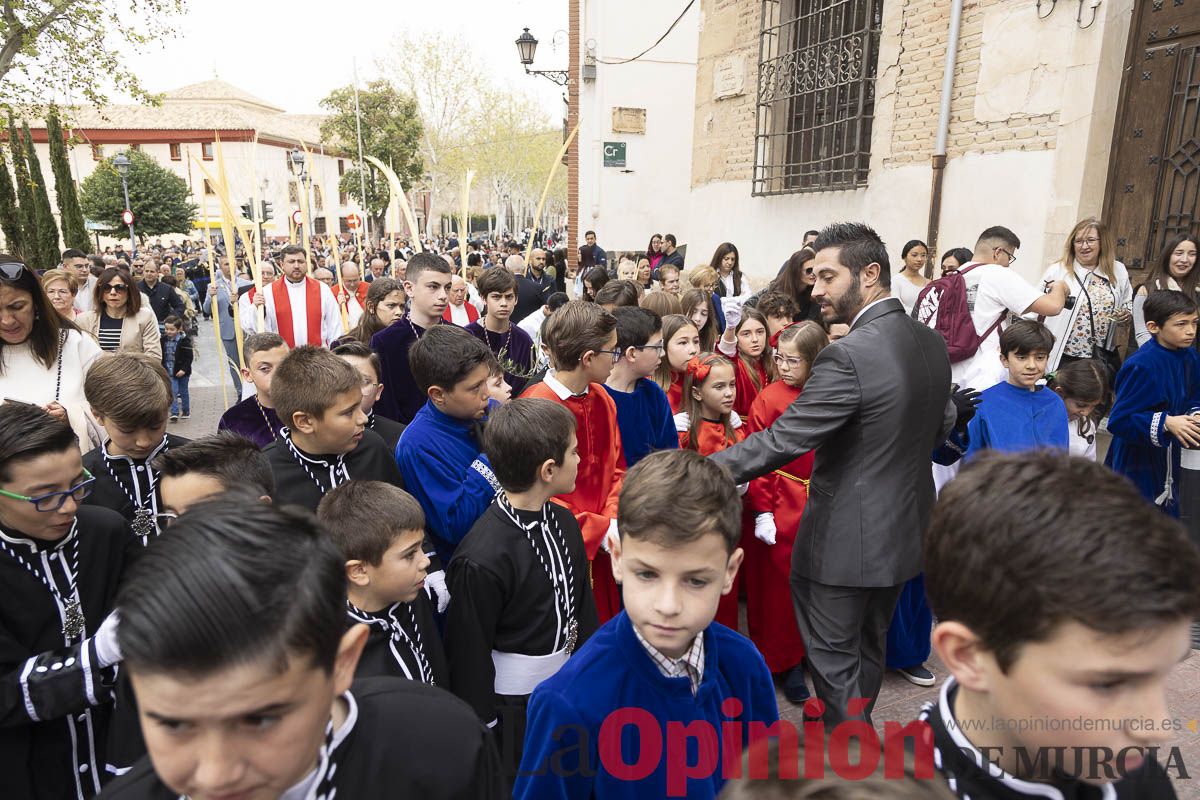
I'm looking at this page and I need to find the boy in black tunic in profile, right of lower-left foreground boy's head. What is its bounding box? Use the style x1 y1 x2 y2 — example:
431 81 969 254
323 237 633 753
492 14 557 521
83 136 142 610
317 481 450 688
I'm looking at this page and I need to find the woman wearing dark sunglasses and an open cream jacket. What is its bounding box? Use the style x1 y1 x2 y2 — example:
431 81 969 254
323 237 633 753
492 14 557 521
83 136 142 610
76 266 162 359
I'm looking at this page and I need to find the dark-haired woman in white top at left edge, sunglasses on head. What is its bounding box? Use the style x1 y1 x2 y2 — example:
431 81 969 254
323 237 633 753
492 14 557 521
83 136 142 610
0 253 100 451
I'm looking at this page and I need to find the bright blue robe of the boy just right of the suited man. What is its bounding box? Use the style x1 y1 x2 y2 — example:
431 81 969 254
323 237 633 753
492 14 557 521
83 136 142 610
966 381 1070 461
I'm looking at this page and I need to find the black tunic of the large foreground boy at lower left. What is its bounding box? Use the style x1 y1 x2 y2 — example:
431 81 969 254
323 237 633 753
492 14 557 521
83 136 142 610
97 678 505 800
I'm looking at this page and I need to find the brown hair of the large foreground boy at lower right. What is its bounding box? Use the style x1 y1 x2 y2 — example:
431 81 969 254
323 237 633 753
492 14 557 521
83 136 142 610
925 452 1200 672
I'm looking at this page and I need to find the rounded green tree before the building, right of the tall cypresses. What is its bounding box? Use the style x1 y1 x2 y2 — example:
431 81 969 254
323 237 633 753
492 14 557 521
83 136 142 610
79 150 197 240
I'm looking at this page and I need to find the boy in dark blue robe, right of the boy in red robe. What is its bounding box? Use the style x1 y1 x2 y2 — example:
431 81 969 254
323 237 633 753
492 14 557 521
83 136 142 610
604 307 679 467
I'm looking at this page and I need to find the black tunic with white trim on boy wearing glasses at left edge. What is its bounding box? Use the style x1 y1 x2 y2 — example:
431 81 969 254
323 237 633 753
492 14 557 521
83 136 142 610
0 506 135 800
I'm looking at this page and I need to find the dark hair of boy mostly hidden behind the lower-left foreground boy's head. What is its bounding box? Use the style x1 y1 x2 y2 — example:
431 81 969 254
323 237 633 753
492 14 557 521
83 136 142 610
154 431 275 497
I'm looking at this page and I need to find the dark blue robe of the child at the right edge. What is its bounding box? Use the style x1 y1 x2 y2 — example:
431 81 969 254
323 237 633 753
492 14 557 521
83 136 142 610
1104 339 1200 517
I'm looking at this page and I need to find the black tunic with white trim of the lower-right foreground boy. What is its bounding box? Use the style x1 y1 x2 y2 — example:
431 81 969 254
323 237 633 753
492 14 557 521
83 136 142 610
917 678 1176 800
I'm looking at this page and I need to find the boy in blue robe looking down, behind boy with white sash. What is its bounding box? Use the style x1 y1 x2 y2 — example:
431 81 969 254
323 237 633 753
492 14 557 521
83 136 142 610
396 325 500 563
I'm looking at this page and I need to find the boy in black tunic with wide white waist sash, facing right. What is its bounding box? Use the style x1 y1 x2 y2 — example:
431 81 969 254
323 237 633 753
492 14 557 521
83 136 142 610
446 398 599 777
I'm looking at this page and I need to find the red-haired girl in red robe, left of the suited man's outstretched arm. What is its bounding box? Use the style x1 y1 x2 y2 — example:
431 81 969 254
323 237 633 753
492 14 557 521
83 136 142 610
676 353 744 631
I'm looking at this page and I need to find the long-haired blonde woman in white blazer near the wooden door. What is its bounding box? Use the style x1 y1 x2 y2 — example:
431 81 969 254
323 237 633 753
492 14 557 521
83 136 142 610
1042 217 1133 372
